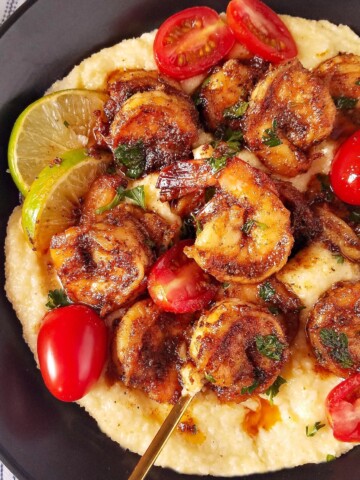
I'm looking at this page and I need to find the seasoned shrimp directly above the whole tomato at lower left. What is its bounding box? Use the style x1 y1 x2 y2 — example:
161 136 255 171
50 205 155 315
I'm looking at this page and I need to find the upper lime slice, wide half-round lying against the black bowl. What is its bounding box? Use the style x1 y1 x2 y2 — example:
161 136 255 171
8 90 108 195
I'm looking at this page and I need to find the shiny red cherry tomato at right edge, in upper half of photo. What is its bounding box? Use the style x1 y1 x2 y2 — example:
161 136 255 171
330 130 360 205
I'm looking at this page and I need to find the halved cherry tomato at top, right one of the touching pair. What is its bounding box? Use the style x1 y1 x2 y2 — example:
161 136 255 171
226 0 297 63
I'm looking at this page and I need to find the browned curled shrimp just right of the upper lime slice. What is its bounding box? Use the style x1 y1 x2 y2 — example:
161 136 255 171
110 91 198 173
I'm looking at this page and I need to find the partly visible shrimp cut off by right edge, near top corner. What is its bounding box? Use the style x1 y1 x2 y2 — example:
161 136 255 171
315 53 360 126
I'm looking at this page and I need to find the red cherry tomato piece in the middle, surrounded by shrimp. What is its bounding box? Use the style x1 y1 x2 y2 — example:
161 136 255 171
148 240 218 313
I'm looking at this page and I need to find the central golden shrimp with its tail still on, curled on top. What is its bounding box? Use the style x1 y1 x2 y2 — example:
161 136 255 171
158 158 293 283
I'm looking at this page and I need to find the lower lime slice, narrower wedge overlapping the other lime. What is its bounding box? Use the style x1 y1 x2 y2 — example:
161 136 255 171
22 149 112 253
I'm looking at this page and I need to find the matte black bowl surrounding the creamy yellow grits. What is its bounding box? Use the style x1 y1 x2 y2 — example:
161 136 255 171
0 0 360 480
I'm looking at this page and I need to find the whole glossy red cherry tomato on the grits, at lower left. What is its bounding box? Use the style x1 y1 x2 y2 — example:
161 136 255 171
37 305 107 402
